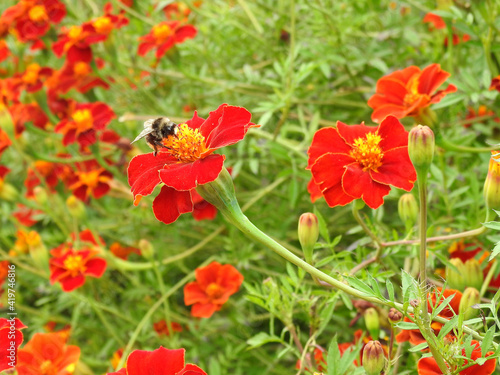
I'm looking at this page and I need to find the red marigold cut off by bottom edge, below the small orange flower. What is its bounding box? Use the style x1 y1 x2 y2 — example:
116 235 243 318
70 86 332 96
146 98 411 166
107 346 207 375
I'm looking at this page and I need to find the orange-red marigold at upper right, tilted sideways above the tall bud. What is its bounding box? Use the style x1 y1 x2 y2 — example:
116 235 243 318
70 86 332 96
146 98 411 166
368 64 457 122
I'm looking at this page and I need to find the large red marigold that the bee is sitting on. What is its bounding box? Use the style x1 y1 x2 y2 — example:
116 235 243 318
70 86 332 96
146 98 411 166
128 104 257 224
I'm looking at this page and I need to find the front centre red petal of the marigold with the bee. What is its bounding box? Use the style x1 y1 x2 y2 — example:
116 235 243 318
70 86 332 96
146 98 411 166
158 155 224 194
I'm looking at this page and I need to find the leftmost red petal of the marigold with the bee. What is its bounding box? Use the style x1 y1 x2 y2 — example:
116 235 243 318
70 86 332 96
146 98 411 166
128 152 177 205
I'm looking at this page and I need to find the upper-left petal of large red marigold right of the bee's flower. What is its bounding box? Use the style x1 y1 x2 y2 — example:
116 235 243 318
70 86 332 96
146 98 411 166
307 128 352 169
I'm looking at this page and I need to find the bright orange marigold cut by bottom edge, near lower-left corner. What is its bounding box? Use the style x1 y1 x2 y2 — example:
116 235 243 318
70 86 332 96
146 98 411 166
17 332 80 375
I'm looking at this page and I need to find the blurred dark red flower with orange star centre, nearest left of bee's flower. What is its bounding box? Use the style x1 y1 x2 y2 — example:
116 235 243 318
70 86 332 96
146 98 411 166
67 160 113 202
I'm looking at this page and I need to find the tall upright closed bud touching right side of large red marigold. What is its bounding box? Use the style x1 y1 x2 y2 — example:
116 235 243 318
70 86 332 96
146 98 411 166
408 125 434 171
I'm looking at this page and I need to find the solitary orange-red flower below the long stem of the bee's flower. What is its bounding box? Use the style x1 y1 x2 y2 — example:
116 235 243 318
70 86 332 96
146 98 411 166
184 262 243 318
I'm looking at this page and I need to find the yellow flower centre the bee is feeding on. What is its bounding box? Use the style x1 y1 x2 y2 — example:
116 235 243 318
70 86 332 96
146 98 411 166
163 124 208 163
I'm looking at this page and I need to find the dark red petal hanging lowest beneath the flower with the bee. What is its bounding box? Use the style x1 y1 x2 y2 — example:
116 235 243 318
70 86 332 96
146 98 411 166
153 186 193 224
